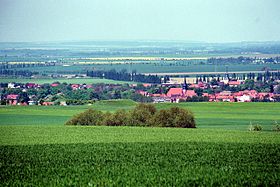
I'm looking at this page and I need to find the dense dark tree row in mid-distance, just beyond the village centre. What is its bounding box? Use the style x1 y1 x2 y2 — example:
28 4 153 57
87 69 161 84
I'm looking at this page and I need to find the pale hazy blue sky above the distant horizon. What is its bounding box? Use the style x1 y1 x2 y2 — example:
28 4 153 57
0 0 280 42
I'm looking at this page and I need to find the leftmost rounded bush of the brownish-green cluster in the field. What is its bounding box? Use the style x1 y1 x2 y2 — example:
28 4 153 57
65 109 104 126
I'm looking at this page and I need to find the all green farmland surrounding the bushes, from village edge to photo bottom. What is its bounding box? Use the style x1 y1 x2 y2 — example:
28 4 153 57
0 100 280 186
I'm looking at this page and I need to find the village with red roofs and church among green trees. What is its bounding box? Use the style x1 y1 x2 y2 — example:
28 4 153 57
0 77 280 106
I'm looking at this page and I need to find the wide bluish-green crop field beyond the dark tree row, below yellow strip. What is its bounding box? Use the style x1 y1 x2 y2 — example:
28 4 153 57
7 61 280 74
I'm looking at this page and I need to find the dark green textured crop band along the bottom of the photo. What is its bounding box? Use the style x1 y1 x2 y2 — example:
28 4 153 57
0 142 280 186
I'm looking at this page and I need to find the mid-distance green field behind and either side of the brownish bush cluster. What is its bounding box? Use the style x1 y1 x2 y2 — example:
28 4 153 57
0 100 280 130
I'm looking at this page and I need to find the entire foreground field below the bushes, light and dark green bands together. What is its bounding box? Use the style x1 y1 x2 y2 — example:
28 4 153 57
0 126 280 186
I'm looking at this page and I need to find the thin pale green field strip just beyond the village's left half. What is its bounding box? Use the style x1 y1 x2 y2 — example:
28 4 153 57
0 78 135 84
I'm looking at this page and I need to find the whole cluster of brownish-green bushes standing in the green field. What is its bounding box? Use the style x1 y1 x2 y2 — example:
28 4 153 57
66 103 196 128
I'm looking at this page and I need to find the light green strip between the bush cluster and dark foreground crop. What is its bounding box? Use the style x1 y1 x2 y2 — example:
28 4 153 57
0 125 280 145
